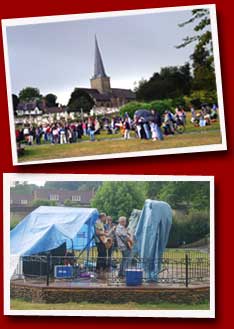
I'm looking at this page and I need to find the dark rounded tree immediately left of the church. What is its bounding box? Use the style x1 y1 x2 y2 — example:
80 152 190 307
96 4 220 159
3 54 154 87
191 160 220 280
68 88 95 113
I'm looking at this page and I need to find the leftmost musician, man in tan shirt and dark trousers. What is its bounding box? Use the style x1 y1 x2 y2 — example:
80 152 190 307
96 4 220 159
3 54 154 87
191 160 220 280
95 213 107 274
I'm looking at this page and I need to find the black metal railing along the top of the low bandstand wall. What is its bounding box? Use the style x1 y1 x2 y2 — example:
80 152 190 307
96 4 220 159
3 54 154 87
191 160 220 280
11 250 210 287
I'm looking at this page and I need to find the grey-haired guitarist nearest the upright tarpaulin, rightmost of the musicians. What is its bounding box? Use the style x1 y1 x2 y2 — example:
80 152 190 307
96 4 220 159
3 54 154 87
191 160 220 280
115 216 132 278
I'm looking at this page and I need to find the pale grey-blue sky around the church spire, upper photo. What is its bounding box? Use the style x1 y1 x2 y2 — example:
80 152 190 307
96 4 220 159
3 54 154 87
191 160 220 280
7 10 207 105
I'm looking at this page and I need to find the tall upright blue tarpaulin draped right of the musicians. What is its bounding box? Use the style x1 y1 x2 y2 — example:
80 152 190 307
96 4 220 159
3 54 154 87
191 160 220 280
134 200 172 281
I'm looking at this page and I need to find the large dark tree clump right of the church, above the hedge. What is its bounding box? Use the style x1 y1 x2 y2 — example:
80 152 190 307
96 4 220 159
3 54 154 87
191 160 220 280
135 63 192 102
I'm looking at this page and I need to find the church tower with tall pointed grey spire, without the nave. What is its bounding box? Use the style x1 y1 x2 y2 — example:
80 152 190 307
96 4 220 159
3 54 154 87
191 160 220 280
90 35 111 94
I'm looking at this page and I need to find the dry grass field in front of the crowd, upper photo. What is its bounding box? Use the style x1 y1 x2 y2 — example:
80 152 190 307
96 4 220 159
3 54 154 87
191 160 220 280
18 115 222 162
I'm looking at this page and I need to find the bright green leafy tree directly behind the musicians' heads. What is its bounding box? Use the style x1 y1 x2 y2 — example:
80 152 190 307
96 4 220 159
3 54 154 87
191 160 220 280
91 182 145 221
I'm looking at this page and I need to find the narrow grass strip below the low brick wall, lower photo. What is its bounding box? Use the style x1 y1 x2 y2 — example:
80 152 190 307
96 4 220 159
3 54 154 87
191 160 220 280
11 299 210 310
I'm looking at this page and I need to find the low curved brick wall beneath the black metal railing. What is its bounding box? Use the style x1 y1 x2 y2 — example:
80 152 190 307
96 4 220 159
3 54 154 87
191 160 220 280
11 283 210 304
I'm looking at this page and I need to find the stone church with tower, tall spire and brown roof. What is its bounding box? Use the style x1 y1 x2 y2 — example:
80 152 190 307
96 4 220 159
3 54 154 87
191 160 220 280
77 36 136 108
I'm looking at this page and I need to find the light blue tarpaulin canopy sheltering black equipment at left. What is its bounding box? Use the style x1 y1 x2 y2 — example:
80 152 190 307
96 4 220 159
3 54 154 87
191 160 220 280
10 206 99 256
